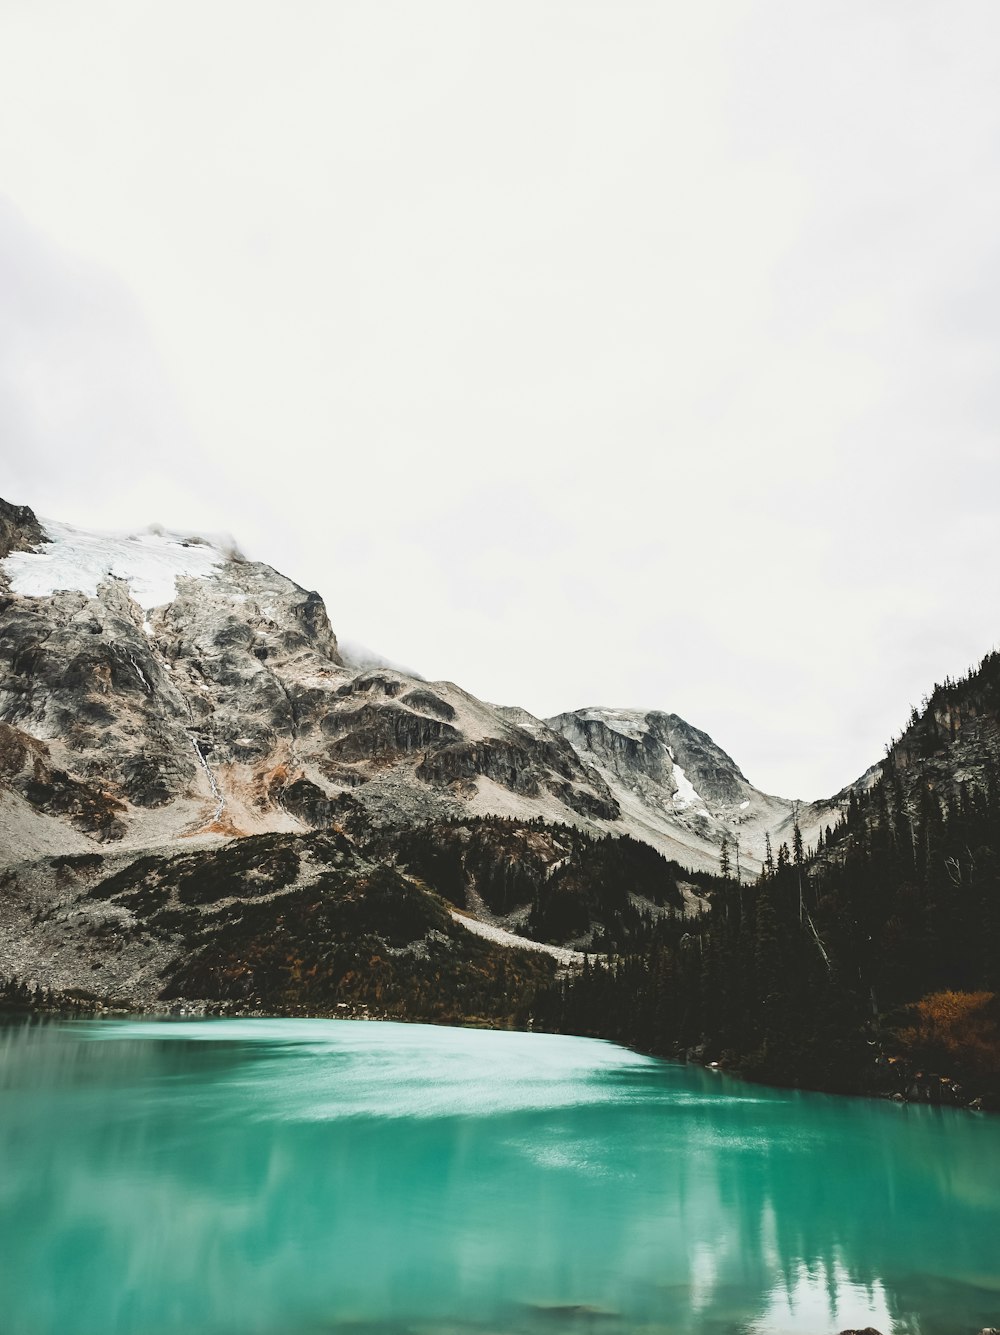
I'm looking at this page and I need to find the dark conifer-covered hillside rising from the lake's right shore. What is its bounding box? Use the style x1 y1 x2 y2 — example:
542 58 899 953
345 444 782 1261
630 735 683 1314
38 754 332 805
546 654 1000 1101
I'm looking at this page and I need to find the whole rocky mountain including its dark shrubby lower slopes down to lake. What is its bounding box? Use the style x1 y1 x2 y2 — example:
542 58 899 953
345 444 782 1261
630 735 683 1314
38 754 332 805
0 502 846 1017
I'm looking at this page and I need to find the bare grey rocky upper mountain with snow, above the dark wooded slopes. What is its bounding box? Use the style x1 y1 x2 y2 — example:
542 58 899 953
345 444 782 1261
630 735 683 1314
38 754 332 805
0 503 843 874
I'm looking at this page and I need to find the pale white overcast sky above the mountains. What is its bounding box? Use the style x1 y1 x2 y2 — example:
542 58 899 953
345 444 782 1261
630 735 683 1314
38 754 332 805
0 0 1000 797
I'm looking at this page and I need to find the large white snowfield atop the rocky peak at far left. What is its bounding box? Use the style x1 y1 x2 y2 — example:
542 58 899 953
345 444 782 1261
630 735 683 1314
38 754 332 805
1 519 226 611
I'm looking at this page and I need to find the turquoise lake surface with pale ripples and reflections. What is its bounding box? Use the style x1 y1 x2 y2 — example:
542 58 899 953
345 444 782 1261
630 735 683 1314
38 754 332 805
0 1020 1000 1335
